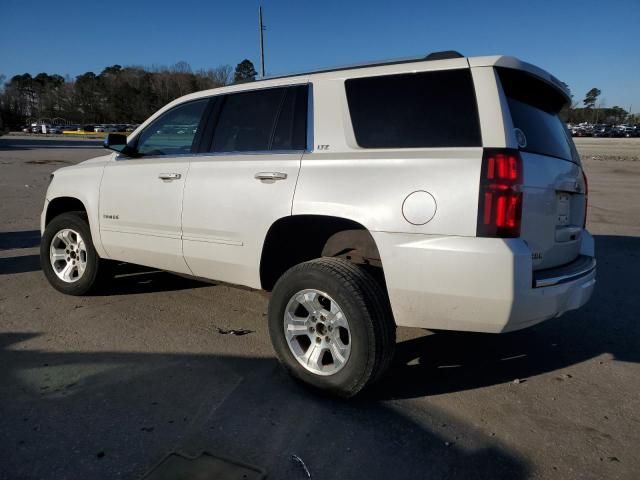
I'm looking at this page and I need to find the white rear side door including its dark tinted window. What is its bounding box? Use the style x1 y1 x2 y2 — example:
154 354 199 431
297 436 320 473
182 84 308 288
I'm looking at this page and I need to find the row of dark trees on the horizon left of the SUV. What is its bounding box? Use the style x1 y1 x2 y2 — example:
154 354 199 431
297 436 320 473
0 59 257 128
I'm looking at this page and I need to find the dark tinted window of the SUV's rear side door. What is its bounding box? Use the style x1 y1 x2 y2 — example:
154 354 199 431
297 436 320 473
211 85 307 152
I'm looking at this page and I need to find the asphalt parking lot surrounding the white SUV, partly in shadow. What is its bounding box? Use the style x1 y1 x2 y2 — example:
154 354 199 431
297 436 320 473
0 136 640 480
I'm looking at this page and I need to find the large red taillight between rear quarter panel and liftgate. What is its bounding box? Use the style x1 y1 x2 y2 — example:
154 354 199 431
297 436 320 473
477 148 522 238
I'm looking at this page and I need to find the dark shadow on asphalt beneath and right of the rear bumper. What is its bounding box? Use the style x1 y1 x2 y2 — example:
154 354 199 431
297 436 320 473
369 235 640 399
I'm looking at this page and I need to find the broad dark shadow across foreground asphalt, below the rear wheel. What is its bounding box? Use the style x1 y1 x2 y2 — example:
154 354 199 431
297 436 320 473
0 332 531 480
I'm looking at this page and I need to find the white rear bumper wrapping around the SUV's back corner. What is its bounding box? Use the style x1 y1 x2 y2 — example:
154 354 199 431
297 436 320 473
373 232 596 333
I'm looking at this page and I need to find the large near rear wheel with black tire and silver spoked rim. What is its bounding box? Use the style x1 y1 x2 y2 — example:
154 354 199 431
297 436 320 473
269 258 395 397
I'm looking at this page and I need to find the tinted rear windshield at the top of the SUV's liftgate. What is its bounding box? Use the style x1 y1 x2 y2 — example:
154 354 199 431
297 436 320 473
496 68 579 163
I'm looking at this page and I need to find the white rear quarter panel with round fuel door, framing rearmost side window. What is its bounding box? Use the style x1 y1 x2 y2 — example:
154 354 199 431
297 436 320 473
293 59 482 236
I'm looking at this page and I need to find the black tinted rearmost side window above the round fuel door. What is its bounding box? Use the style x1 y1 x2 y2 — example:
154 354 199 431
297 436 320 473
345 69 482 148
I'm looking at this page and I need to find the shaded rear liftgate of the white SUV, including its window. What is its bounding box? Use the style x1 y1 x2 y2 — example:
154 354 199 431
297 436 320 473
496 68 587 270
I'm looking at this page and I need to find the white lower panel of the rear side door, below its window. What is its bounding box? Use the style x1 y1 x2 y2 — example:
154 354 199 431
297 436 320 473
182 152 304 288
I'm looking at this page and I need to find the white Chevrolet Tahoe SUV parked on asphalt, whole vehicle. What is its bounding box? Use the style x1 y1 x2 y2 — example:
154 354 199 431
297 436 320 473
41 53 595 396
